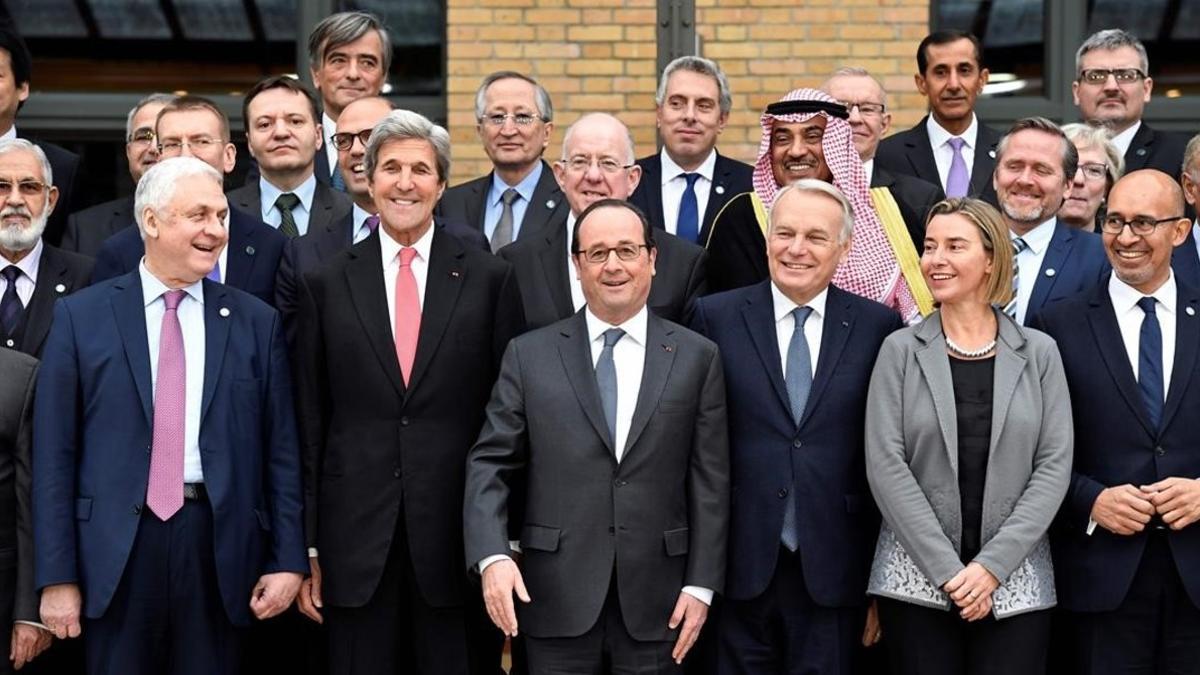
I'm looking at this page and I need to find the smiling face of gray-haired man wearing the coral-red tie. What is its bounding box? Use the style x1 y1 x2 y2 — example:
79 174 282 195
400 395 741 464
371 138 445 246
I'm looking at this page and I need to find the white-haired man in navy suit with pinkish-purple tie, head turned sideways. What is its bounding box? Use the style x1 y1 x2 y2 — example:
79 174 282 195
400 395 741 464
34 159 308 675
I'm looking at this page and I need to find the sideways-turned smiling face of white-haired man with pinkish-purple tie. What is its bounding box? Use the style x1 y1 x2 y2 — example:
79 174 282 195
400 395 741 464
143 175 229 288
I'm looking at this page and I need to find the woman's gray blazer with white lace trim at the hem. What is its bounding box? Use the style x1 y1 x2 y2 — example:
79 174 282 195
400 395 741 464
866 311 1074 617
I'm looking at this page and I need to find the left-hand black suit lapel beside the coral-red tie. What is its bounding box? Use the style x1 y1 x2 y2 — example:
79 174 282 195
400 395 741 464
346 231 405 398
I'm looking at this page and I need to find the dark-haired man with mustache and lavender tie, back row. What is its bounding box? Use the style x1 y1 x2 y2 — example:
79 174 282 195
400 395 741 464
876 30 1000 204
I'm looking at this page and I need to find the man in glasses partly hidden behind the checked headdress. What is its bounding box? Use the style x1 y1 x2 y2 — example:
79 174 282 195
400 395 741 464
821 67 946 255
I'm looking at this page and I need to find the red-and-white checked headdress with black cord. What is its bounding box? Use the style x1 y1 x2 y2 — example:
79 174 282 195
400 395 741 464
754 89 920 323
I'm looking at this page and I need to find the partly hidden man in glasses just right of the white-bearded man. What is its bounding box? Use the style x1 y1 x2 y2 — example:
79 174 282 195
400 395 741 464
62 94 175 258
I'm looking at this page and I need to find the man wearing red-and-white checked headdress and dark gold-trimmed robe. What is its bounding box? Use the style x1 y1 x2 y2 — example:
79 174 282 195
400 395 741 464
706 89 920 323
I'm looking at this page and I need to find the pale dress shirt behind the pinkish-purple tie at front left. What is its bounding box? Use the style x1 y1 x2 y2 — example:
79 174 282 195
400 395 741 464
138 258 204 483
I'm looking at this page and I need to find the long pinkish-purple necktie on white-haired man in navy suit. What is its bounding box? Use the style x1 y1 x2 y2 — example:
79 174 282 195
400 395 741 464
146 291 187 520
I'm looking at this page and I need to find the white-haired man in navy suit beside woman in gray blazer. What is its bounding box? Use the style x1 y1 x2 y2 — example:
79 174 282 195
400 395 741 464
691 180 902 674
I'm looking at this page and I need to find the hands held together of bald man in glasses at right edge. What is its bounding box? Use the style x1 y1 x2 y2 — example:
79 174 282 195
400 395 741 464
1092 476 1200 536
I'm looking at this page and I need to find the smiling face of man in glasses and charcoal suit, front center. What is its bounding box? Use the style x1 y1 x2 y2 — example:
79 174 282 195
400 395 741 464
571 201 656 325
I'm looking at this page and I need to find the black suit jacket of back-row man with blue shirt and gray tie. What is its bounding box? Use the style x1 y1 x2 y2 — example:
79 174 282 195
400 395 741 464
433 160 570 241
